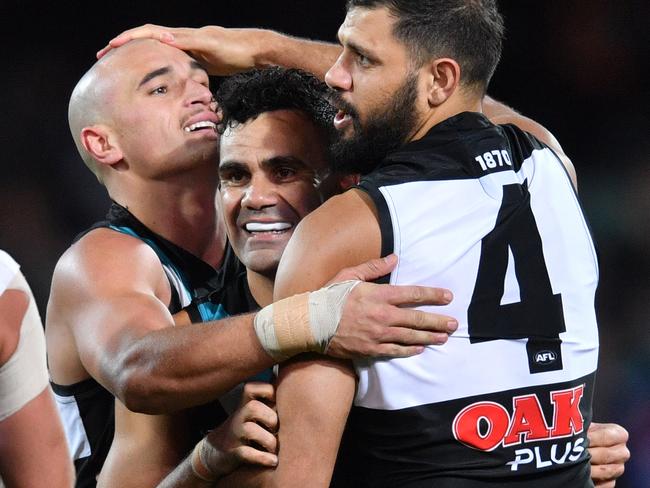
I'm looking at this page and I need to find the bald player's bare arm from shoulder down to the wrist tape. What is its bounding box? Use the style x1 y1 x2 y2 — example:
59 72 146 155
46 229 273 413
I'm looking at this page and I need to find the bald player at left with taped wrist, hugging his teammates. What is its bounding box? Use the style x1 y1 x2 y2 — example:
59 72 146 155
46 39 460 487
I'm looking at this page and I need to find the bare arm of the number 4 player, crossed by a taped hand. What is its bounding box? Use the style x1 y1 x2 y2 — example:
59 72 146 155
223 190 381 487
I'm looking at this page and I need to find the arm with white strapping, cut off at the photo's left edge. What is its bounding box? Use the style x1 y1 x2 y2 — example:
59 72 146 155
0 266 74 488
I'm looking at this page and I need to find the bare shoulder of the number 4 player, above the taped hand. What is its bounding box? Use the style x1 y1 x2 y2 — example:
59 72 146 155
275 189 381 297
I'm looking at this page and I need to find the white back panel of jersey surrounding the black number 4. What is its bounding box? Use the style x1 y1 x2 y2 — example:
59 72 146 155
355 149 598 410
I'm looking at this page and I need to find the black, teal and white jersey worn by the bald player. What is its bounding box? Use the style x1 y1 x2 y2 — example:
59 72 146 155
51 203 256 488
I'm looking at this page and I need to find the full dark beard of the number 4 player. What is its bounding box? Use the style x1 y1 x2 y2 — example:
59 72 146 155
331 74 418 174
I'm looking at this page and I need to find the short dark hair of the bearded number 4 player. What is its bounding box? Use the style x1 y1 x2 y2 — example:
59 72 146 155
347 0 504 91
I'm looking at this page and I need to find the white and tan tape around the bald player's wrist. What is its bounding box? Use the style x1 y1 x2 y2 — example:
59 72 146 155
254 280 361 362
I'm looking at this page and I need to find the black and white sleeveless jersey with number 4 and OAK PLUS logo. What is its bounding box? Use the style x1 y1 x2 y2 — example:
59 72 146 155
333 112 598 488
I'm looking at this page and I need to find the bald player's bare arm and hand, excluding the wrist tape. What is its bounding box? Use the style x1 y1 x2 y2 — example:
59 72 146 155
47 229 449 413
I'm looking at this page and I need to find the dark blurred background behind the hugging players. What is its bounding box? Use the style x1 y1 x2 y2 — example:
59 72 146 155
0 0 650 488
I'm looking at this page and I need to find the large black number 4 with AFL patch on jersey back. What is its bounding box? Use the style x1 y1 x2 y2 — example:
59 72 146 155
468 182 566 373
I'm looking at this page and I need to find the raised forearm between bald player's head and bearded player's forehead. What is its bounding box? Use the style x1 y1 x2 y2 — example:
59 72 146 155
255 31 341 80
